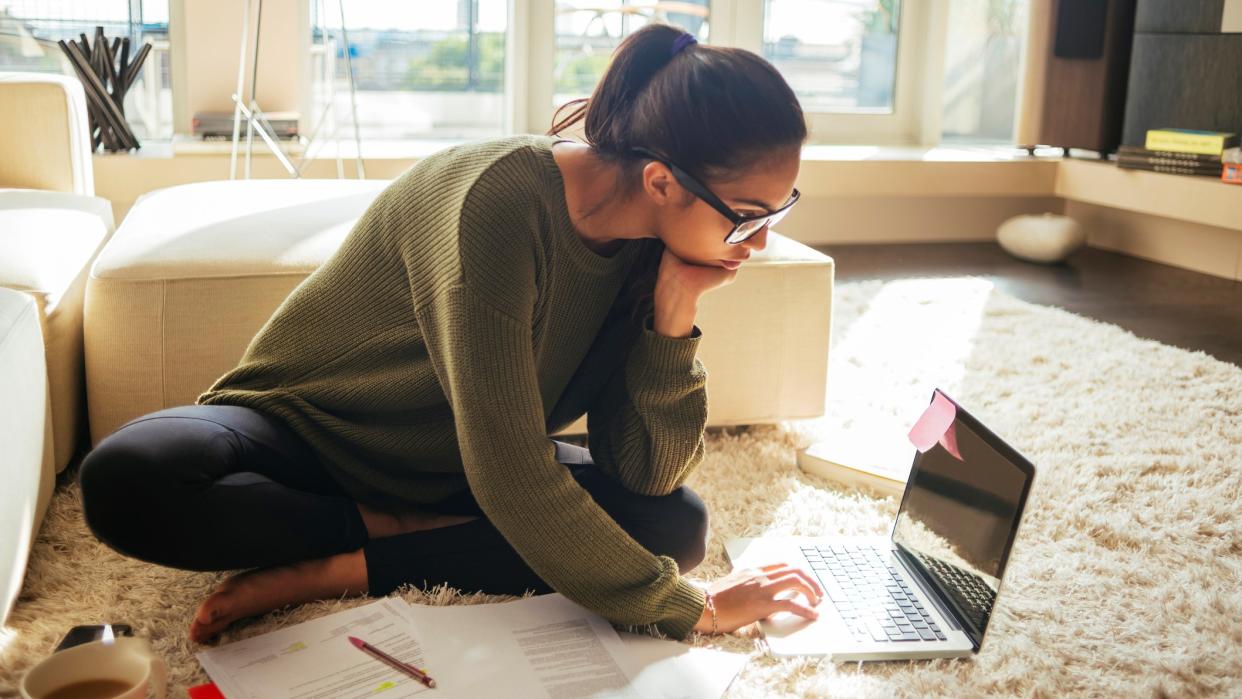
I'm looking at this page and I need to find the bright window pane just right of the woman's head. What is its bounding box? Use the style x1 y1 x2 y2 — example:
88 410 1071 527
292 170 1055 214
764 0 902 113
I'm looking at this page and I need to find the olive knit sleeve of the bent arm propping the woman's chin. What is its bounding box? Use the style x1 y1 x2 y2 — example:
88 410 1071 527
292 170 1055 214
586 314 707 495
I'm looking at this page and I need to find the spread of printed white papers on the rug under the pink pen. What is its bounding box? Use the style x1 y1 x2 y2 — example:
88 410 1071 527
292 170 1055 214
197 595 746 699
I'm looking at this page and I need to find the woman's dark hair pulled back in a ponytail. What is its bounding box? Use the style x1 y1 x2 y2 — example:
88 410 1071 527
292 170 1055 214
548 24 806 320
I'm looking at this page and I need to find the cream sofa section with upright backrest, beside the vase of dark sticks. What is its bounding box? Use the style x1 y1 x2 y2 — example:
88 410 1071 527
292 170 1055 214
0 73 113 474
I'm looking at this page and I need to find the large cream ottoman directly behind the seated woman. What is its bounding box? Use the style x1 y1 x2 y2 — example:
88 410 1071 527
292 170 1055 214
86 180 832 443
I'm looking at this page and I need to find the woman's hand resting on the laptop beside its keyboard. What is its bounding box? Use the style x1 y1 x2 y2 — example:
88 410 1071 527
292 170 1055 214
694 564 823 633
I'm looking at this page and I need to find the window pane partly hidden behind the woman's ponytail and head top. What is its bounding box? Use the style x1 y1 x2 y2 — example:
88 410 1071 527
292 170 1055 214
553 0 708 106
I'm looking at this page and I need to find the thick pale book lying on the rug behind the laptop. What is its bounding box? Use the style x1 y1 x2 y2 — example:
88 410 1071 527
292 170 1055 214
797 435 914 499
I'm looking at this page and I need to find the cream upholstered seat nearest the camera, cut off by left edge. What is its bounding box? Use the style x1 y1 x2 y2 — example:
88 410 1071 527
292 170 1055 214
0 288 56 627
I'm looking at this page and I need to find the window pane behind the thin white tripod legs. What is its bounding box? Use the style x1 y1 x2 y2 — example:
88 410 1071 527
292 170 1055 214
312 0 508 140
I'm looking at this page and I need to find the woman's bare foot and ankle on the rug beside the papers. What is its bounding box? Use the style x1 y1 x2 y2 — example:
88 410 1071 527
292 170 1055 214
190 549 366 643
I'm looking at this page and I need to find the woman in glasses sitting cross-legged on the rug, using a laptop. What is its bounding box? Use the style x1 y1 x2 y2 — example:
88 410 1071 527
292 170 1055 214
81 25 821 642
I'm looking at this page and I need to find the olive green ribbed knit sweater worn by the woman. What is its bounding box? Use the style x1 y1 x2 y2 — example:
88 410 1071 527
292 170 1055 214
197 135 707 638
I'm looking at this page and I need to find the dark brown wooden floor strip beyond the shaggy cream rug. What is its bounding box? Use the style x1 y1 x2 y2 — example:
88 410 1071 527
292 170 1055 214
815 242 1242 365
